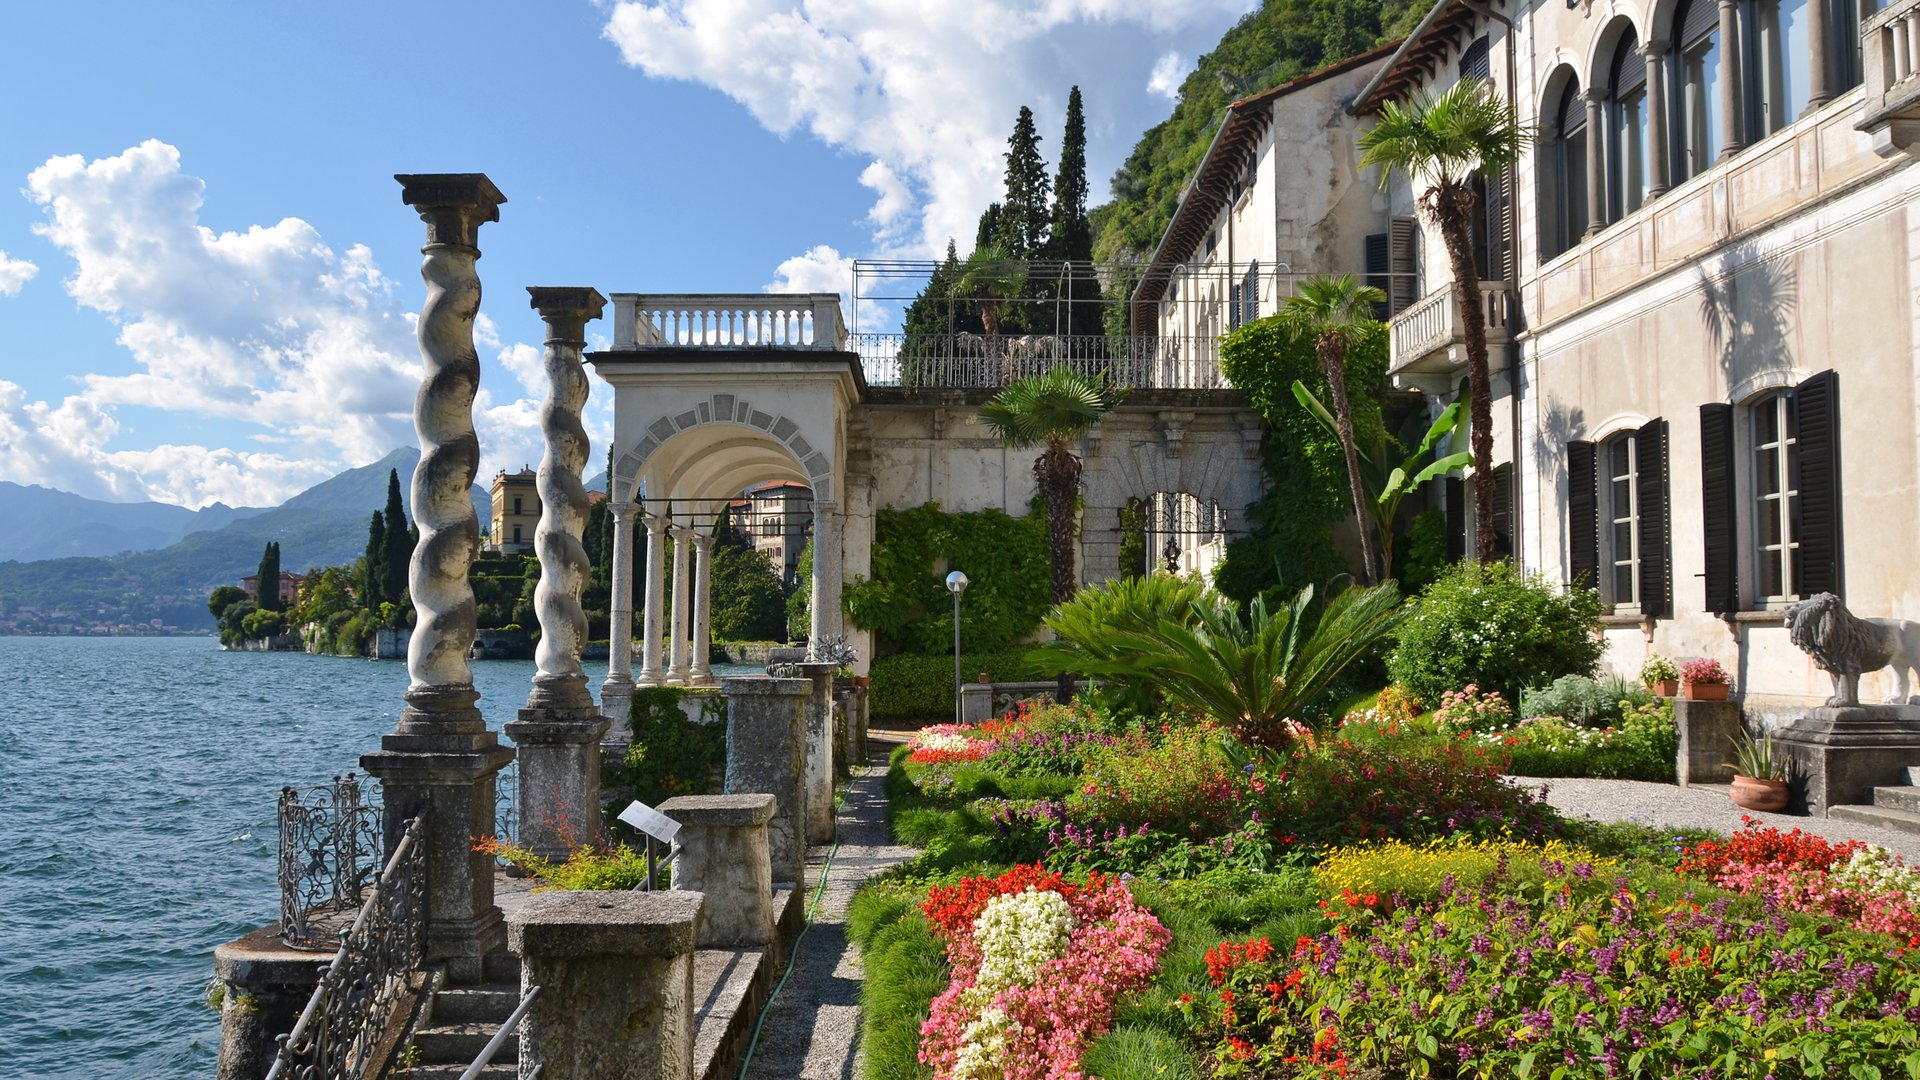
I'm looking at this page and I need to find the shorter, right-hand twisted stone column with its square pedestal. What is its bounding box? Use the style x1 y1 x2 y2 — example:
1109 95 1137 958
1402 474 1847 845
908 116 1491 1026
507 288 612 859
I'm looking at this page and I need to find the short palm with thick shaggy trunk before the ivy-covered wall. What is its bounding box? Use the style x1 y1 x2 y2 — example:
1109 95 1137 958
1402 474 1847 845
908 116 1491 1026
979 367 1119 701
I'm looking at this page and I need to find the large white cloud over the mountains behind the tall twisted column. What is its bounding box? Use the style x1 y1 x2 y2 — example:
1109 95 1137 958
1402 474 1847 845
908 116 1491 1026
13 140 545 505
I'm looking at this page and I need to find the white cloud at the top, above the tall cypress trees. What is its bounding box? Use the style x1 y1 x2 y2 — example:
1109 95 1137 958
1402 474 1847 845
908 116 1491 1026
605 0 1250 258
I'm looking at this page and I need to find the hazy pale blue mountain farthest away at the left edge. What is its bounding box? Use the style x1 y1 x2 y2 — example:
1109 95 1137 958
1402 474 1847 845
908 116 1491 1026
0 480 265 561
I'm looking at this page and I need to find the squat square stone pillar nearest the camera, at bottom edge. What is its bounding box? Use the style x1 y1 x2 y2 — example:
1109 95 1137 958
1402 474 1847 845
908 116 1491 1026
507 892 703 1080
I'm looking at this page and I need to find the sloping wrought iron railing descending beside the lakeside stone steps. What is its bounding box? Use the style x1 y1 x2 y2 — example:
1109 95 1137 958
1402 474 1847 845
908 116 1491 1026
267 817 426 1080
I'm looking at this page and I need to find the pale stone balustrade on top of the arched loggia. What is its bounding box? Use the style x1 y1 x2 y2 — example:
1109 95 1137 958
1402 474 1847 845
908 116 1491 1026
612 292 847 350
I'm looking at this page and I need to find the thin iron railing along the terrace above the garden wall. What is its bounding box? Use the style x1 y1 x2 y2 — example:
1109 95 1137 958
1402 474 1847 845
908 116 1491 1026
849 332 1227 390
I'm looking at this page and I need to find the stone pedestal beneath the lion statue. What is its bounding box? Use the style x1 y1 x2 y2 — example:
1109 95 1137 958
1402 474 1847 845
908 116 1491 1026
1774 705 1920 817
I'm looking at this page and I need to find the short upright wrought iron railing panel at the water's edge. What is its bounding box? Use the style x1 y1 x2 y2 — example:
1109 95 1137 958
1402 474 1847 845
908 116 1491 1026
280 773 380 949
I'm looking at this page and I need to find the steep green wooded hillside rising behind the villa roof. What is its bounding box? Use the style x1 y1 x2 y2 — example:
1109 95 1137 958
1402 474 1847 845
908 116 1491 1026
1092 0 1428 265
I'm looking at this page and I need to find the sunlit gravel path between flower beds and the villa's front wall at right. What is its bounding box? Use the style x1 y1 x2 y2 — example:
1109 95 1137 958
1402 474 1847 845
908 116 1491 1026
1507 776 1920 863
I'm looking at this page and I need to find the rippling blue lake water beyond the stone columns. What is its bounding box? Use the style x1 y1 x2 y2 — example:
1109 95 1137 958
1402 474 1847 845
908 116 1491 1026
0 638 729 1080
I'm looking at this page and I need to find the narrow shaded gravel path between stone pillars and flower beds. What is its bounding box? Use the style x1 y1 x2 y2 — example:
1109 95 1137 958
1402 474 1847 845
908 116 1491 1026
747 740 916 1080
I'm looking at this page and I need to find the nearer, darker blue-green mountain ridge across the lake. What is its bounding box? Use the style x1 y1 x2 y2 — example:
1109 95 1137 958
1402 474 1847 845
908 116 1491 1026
0 450 492 632
